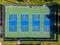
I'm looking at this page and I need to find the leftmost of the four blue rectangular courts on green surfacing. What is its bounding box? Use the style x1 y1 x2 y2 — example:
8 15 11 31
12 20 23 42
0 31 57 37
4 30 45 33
9 14 17 32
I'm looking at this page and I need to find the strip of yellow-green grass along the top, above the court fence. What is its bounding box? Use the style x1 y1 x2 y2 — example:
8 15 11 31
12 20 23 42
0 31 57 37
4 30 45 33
0 0 60 4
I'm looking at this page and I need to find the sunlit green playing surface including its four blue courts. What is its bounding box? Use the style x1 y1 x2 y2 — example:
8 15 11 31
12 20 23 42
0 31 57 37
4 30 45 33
5 6 53 38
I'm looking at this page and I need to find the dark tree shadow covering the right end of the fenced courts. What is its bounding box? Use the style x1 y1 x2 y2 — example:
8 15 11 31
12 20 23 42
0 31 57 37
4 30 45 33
46 4 58 40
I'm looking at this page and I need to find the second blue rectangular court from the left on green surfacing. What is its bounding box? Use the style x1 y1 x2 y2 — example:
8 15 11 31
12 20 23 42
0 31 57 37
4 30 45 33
21 14 29 32
